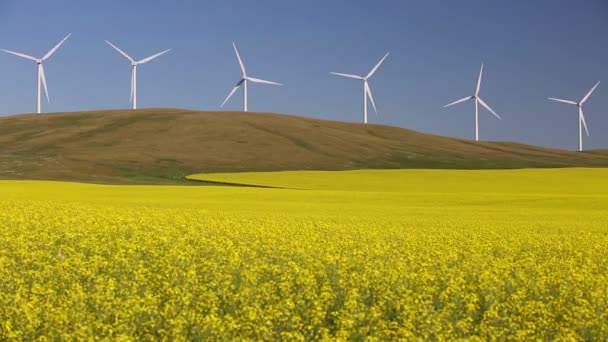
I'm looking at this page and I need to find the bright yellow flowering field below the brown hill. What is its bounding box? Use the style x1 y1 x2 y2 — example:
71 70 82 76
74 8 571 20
0 169 608 341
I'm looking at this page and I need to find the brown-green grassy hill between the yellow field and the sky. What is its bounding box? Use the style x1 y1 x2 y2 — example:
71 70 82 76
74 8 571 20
0 109 608 184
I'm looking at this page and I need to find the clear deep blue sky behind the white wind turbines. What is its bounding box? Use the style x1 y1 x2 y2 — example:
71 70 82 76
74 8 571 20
0 0 608 149
